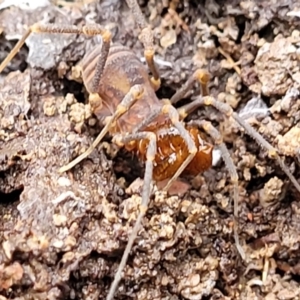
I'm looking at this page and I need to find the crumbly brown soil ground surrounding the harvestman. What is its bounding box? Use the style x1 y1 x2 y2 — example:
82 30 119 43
0 0 300 300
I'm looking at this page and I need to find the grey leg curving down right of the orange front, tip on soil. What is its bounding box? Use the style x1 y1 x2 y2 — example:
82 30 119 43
189 120 246 260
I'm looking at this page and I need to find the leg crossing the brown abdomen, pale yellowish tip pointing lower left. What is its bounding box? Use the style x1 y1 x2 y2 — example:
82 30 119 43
59 85 144 173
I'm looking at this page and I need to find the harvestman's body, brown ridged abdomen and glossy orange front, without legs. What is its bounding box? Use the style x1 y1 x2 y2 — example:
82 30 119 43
81 46 213 181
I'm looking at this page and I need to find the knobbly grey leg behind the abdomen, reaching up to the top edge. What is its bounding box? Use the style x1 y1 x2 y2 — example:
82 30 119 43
126 0 161 90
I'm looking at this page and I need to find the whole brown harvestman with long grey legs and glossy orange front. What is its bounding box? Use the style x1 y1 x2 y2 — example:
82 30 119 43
0 0 300 300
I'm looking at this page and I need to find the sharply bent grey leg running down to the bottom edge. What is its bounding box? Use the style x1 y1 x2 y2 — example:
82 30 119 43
106 132 157 300
